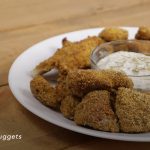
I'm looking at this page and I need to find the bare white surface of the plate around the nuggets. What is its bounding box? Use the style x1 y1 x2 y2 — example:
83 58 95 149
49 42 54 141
9 27 150 141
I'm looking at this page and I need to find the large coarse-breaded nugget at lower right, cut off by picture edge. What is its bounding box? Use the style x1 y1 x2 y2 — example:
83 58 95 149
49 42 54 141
115 88 150 133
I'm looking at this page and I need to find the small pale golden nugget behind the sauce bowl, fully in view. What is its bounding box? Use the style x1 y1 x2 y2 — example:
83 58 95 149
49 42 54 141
99 28 128 42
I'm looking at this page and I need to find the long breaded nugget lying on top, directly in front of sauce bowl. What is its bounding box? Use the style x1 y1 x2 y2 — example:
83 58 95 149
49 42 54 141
67 69 133 97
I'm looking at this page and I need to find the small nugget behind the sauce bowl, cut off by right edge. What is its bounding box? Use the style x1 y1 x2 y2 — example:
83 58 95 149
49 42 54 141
135 26 150 40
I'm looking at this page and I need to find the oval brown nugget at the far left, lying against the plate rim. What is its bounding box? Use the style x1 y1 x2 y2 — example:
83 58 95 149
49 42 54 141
30 75 60 109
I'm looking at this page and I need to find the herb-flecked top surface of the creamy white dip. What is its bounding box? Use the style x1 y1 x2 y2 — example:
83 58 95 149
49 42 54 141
97 51 150 76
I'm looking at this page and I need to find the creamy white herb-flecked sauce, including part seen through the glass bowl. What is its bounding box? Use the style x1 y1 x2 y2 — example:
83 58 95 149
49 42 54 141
97 51 150 91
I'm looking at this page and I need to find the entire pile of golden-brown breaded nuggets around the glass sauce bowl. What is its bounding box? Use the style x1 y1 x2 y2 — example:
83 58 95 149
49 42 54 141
30 27 150 133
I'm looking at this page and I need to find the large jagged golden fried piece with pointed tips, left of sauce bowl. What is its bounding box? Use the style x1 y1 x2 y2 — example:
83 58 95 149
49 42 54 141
33 36 104 75
